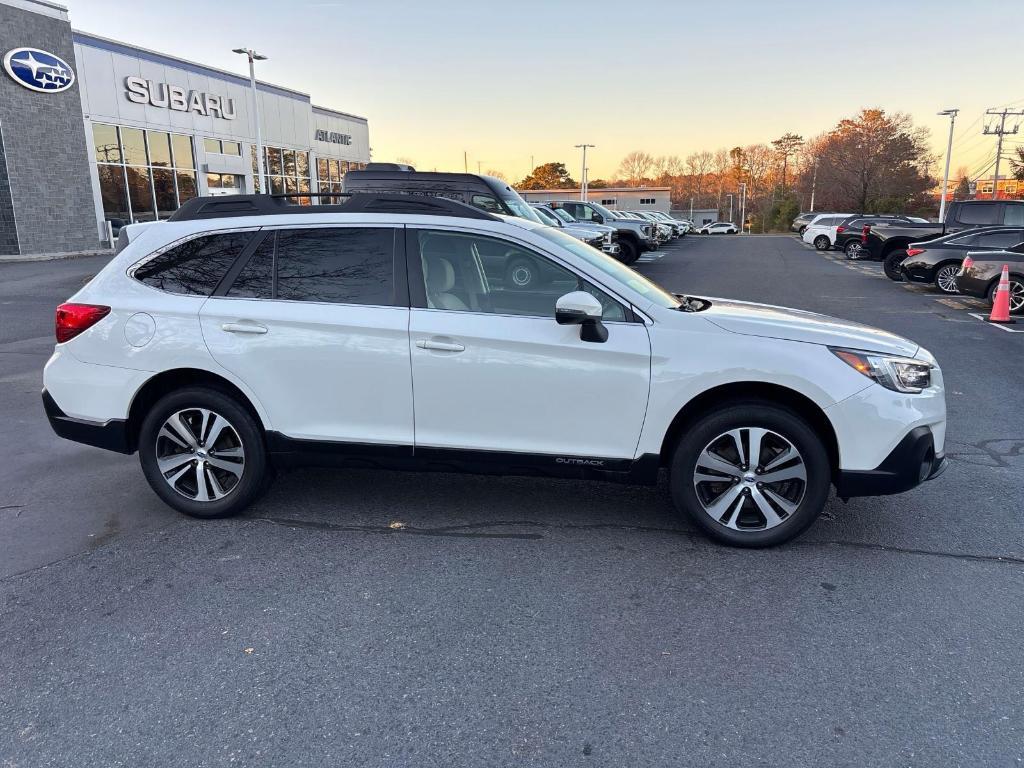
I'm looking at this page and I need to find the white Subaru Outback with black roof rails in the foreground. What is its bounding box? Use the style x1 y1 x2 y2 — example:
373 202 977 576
43 195 946 547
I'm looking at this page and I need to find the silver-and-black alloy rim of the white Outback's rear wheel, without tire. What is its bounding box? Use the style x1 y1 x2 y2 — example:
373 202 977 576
156 408 246 503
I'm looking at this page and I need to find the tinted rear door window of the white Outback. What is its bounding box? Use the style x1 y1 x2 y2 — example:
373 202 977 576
227 227 394 306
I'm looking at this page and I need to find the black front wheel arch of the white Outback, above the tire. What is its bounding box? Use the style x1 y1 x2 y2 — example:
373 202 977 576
660 381 840 477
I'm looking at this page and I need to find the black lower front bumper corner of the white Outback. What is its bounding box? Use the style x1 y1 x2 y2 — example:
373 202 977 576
836 427 946 499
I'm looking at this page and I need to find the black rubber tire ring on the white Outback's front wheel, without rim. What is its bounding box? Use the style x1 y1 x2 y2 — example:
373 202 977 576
669 400 831 547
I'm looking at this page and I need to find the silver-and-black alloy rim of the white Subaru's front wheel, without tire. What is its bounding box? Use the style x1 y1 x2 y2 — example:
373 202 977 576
693 427 807 531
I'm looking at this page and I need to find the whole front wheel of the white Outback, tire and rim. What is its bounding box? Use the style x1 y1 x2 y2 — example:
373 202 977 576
670 401 831 547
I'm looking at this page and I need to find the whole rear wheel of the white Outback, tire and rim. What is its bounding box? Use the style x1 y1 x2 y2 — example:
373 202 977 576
138 387 269 518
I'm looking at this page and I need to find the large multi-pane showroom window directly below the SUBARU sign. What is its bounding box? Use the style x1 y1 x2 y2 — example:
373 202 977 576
92 123 199 228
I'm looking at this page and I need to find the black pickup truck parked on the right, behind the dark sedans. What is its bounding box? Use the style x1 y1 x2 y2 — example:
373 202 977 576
861 200 1024 260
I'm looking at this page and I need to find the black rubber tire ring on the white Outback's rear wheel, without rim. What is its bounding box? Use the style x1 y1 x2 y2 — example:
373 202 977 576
138 387 272 519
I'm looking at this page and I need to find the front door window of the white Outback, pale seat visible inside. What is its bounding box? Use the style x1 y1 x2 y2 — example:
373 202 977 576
413 227 626 321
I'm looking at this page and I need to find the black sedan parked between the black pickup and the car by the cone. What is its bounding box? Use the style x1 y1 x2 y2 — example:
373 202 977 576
885 226 1024 294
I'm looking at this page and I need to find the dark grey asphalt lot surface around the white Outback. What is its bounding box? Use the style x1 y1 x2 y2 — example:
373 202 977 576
0 236 1024 767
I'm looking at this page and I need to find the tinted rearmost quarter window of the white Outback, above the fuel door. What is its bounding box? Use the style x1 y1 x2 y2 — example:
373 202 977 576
133 232 253 296
